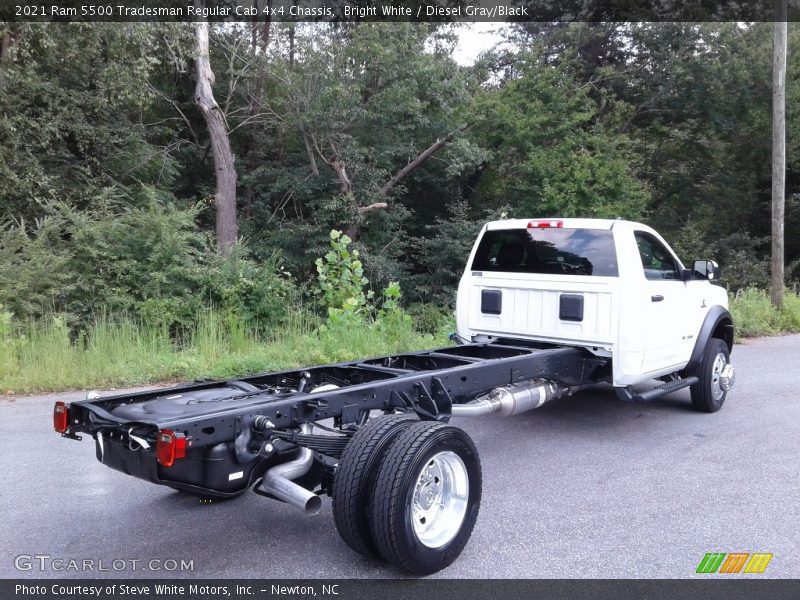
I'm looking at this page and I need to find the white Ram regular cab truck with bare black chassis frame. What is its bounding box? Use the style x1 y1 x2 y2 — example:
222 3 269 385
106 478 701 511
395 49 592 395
53 219 734 575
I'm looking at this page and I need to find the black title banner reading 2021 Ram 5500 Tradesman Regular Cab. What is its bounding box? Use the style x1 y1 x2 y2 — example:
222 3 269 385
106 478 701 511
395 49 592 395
0 0 800 22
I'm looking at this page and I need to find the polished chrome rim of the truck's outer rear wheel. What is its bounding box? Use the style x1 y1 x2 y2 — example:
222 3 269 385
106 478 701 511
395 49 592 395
411 450 469 548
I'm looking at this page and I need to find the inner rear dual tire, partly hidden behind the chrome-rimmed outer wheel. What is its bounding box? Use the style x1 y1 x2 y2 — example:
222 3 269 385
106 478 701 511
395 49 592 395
332 415 416 558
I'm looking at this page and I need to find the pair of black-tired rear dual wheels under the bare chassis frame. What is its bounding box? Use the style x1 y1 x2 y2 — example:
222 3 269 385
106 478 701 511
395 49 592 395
333 417 481 575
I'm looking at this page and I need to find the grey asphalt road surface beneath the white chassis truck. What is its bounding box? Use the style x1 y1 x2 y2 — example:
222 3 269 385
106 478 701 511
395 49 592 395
0 335 800 578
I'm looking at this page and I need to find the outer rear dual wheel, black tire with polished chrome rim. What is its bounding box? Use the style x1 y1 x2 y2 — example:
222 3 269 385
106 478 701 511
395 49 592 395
370 421 481 575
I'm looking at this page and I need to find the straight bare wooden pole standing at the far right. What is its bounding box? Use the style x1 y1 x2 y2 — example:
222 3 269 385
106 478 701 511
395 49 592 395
770 14 787 308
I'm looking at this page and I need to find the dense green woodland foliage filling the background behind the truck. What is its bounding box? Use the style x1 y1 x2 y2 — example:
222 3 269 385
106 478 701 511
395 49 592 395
0 22 800 329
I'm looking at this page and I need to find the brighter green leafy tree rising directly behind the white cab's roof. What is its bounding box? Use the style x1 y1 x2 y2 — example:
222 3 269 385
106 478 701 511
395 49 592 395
473 53 649 218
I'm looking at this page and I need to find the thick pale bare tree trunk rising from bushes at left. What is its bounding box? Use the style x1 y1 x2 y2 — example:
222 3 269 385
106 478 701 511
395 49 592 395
195 21 238 254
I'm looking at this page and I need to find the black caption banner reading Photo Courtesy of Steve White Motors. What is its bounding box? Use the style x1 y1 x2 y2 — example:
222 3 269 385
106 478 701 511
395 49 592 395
0 575 800 600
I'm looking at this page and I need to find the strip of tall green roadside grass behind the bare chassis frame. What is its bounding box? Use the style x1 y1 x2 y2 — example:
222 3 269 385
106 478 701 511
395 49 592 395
0 310 452 393
